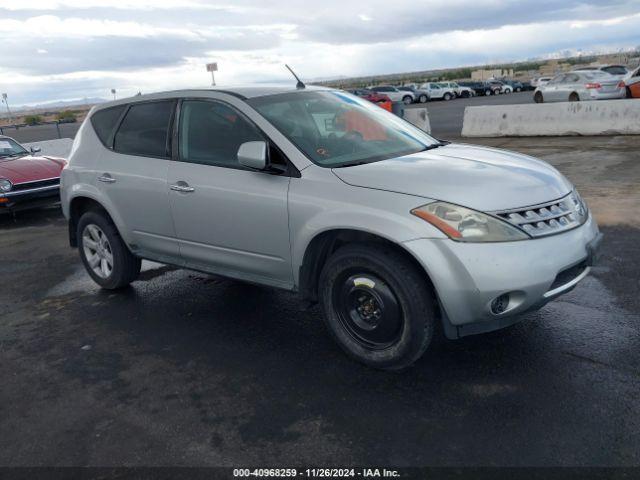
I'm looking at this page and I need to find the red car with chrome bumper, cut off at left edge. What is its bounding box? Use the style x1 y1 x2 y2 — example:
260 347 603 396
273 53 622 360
0 136 66 214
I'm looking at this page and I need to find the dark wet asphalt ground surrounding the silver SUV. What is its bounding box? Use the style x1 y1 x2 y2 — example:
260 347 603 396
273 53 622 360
0 134 640 467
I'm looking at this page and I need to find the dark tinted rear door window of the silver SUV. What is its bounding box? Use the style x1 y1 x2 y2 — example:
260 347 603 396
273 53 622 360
113 100 175 158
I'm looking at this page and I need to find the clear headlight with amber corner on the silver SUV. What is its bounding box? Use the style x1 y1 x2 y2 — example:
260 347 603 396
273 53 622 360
411 202 531 242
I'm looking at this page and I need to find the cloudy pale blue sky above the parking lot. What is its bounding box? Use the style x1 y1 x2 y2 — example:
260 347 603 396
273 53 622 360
0 0 640 105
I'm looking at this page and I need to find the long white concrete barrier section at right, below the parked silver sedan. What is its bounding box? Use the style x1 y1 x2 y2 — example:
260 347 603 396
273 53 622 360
462 99 640 137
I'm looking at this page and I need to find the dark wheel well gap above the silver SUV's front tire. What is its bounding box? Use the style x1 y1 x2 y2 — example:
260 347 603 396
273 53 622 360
298 229 437 303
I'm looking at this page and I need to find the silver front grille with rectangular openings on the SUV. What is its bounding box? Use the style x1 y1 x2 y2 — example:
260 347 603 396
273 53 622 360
493 193 587 237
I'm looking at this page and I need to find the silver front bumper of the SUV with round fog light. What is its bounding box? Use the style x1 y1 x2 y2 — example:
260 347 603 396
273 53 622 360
404 214 602 338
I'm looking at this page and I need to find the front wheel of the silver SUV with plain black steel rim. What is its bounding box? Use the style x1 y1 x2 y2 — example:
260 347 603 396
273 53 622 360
319 244 436 370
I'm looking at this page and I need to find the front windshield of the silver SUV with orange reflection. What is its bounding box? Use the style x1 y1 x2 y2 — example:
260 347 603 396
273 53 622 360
248 91 440 168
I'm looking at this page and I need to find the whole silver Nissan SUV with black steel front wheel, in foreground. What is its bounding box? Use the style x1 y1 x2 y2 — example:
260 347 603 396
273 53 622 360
61 87 601 369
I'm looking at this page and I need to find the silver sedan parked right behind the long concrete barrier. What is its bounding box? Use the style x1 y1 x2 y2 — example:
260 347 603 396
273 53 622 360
533 70 626 103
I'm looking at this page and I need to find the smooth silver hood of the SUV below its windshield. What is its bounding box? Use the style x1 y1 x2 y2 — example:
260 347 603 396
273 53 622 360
333 144 572 211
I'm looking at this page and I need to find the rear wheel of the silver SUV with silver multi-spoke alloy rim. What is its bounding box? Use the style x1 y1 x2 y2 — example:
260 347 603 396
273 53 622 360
77 210 141 290
